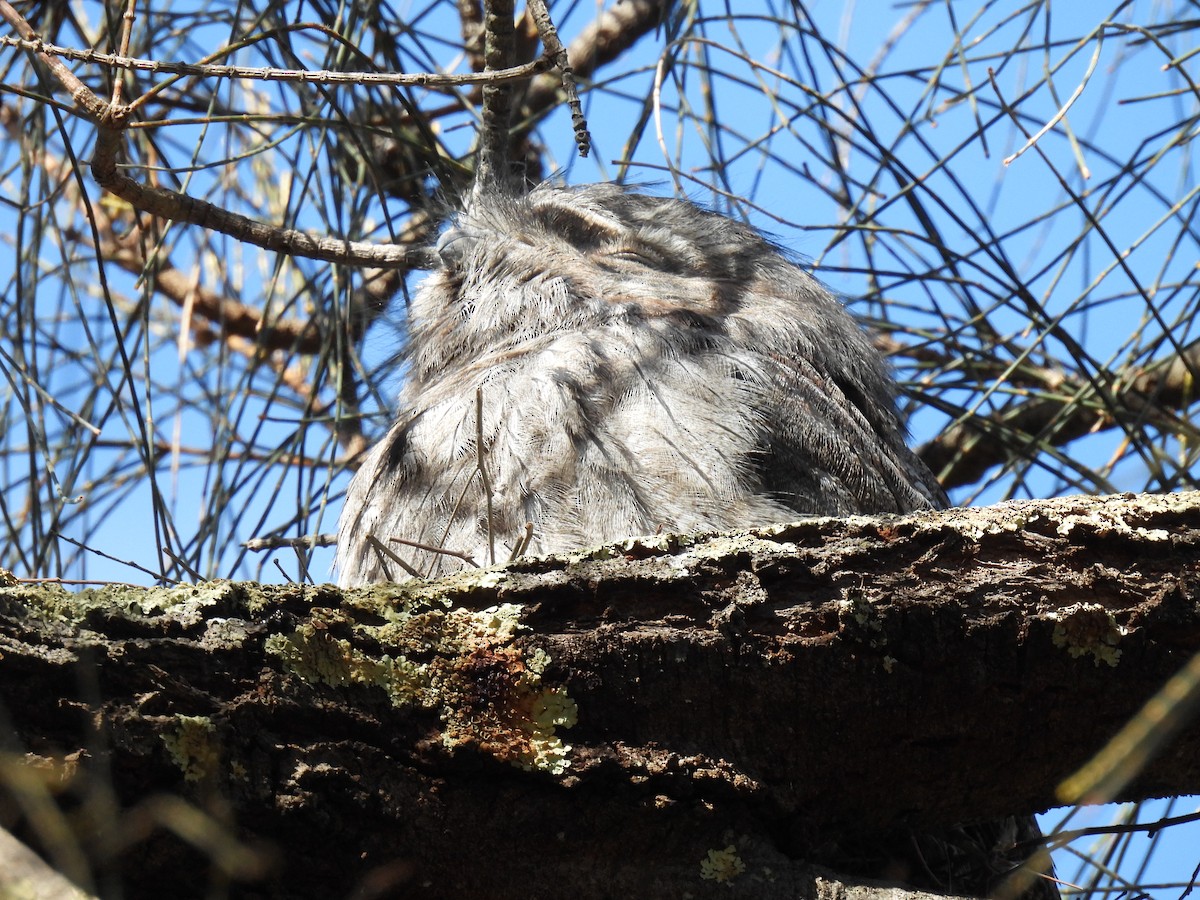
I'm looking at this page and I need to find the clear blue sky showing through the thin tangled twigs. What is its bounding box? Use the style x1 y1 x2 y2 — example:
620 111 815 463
0 0 1200 896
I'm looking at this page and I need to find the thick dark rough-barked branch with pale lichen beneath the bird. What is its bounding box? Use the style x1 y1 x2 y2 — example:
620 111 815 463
0 493 1200 898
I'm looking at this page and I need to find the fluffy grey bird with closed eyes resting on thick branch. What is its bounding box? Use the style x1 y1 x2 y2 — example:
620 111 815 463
336 182 1057 900
